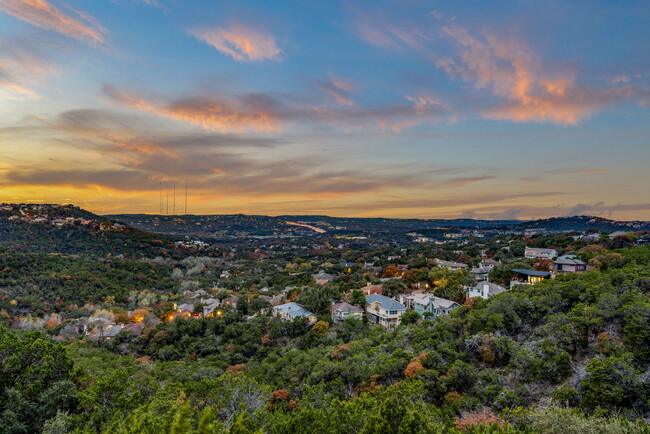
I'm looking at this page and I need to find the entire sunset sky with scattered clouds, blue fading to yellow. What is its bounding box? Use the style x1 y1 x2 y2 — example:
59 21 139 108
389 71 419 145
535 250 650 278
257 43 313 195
0 0 650 220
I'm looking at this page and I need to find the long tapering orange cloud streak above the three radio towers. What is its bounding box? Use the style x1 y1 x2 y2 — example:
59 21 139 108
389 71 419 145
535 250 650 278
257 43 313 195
104 86 280 132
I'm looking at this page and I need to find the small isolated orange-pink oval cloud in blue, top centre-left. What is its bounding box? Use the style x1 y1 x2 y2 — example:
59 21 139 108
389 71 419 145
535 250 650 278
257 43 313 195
190 24 282 62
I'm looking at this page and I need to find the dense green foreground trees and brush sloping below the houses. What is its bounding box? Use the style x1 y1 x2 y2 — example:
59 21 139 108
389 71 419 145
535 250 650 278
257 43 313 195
0 247 650 433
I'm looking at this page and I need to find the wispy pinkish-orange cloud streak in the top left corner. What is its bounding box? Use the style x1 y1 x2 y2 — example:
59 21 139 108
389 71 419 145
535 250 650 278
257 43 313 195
0 0 106 43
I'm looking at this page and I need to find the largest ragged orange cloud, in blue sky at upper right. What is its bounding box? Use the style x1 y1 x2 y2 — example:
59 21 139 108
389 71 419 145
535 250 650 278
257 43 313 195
436 24 633 125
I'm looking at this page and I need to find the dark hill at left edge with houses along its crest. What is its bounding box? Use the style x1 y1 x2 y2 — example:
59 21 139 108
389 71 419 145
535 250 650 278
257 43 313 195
0 204 174 258
